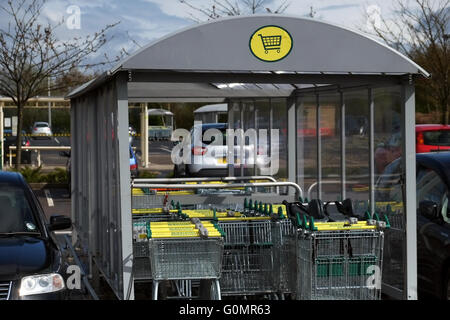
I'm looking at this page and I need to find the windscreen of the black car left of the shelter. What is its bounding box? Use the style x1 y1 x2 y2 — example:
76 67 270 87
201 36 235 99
0 184 39 233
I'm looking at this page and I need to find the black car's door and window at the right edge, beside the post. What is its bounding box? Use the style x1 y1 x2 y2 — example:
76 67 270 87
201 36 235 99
416 166 449 295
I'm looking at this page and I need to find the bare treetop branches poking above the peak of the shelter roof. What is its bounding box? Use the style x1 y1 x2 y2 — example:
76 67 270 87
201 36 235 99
178 0 289 22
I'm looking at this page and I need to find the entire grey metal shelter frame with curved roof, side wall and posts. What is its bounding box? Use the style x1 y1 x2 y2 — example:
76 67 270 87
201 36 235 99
68 15 429 299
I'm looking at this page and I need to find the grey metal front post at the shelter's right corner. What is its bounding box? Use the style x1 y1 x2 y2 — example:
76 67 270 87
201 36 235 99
402 79 417 300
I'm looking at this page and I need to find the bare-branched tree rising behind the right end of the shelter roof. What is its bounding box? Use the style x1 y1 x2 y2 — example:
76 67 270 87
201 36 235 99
367 0 450 124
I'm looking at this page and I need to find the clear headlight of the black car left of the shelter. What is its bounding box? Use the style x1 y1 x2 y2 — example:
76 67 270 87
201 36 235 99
19 273 64 297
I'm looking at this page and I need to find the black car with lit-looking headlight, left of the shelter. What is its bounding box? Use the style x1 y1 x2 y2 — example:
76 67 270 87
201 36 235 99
0 171 71 300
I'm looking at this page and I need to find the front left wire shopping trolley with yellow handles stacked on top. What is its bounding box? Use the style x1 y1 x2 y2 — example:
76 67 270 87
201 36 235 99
148 221 223 300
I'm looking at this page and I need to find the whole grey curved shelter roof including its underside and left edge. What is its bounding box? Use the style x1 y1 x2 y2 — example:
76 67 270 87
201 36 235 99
69 14 429 102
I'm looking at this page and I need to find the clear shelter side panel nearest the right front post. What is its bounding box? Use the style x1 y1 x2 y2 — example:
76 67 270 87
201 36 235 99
372 87 406 296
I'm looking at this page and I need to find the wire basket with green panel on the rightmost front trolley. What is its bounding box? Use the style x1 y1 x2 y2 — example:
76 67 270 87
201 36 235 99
291 227 384 300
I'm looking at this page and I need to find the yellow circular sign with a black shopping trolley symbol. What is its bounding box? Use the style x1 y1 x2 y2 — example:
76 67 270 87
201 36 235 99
250 26 293 62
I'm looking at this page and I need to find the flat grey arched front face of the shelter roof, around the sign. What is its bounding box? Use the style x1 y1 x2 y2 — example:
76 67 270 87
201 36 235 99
114 15 428 75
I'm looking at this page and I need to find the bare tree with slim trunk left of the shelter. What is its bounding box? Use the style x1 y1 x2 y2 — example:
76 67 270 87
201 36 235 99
0 0 120 169
